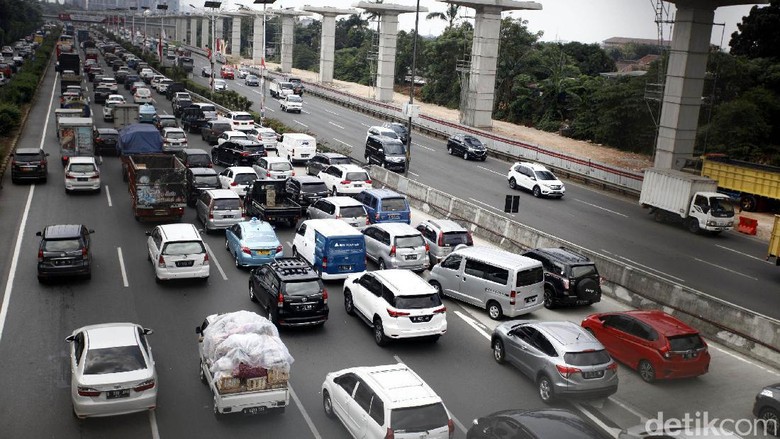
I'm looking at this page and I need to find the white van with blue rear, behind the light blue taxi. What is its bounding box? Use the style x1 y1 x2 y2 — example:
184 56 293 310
293 219 366 279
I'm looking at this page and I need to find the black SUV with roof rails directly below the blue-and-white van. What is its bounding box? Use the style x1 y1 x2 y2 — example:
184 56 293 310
249 257 329 326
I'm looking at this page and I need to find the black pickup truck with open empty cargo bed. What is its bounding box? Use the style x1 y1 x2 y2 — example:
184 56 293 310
244 179 301 227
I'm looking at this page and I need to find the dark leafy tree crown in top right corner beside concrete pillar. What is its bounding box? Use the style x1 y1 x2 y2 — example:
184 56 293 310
729 0 780 60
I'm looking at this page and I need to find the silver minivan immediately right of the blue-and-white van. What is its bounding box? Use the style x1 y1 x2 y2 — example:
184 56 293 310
363 223 429 272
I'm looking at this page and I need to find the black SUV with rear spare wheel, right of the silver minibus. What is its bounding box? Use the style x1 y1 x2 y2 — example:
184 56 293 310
523 247 601 308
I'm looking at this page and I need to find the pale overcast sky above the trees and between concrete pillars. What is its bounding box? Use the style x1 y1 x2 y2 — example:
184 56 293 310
201 0 768 49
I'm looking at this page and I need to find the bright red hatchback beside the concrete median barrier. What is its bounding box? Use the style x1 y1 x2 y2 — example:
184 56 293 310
582 310 710 383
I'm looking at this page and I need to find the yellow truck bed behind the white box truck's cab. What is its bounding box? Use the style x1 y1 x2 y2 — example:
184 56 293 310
701 156 780 212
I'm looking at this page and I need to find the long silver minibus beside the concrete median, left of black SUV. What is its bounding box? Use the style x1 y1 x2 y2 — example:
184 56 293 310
428 247 544 320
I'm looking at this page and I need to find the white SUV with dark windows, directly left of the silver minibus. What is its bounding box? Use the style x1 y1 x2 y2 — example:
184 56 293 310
344 269 447 346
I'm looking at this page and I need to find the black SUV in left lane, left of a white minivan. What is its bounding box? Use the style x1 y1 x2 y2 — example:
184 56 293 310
36 224 95 282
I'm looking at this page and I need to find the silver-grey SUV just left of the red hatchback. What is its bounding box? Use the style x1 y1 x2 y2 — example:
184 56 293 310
490 321 618 403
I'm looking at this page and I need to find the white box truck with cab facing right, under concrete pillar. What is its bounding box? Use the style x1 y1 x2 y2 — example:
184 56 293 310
639 168 734 235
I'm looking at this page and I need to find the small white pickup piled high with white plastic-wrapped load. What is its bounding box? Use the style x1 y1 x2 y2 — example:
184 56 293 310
195 311 293 415
